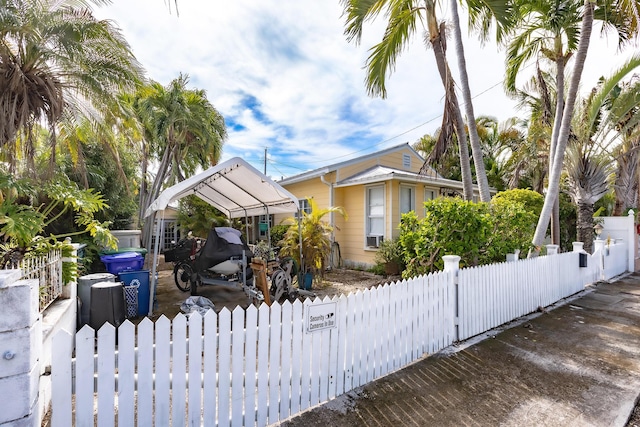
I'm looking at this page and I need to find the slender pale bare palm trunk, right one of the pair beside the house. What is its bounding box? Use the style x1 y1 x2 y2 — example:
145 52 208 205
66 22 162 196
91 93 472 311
451 0 491 202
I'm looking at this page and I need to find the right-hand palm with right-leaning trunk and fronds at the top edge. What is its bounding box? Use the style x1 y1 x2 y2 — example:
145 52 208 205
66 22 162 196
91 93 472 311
506 0 637 255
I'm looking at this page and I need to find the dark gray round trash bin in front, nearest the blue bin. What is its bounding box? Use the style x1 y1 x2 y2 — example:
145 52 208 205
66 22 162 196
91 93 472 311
89 282 127 331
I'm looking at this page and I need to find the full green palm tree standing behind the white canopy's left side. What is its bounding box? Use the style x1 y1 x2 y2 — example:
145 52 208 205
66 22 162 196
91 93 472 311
134 75 227 251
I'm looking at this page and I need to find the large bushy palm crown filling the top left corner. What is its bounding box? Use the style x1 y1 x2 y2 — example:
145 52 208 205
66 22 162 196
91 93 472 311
0 0 142 175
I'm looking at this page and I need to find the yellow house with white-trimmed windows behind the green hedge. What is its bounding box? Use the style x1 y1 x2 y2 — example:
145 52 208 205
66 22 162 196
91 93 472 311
274 143 490 267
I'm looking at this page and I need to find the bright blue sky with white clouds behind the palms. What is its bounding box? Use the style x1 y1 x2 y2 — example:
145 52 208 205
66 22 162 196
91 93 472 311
95 0 631 179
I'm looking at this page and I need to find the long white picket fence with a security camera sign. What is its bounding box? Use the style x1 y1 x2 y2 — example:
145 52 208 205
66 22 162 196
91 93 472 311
52 246 625 427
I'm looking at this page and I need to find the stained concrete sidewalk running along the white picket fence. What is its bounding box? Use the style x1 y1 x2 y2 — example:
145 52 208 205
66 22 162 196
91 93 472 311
281 274 640 427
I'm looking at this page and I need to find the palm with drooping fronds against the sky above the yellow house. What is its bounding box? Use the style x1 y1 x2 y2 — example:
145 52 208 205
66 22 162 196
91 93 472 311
342 0 502 201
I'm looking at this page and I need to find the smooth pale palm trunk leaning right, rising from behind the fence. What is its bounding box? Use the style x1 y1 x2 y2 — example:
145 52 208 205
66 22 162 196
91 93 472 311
529 0 593 257
